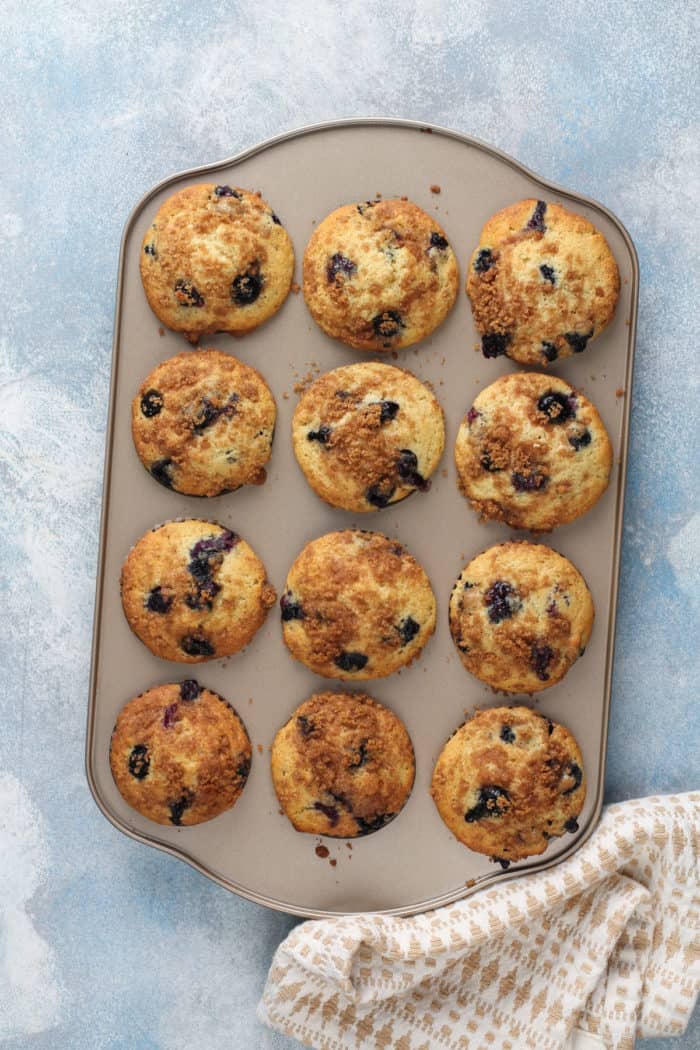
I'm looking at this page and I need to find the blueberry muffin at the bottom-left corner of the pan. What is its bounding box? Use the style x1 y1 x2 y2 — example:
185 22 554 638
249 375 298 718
109 679 251 826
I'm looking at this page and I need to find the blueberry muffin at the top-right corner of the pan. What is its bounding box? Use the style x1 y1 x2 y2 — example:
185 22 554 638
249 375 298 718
467 201 620 368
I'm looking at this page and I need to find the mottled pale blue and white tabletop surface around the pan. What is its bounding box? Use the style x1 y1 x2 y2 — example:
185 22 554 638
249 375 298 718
0 0 700 1050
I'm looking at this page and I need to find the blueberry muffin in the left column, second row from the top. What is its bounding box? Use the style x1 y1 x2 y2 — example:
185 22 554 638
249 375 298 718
131 350 276 496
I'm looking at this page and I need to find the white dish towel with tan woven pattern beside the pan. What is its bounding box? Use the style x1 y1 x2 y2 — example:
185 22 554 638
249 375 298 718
258 793 700 1050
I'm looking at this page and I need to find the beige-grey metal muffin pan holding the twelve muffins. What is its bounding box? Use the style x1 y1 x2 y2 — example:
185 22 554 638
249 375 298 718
86 120 638 917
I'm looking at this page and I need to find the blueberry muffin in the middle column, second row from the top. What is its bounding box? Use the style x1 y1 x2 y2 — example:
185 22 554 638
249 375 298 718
292 361 445 511
